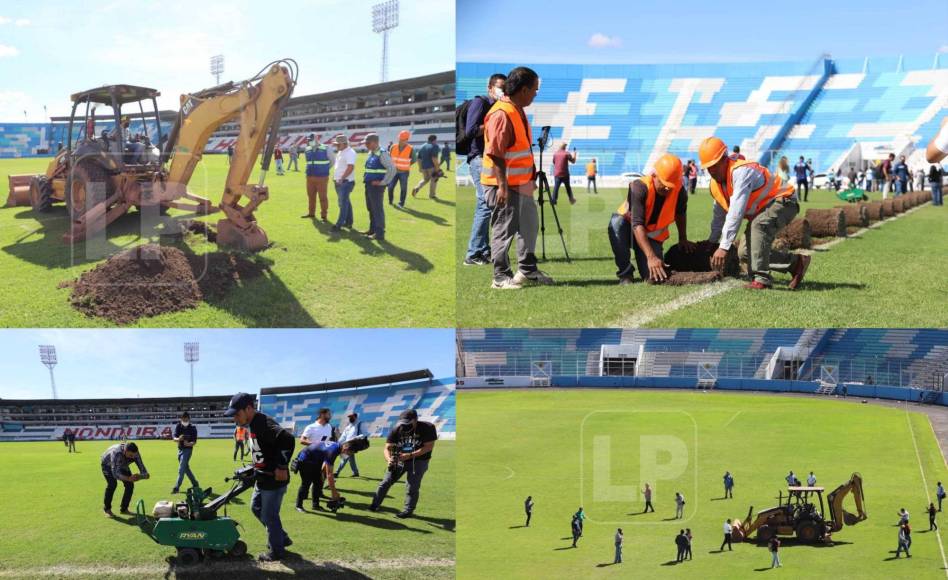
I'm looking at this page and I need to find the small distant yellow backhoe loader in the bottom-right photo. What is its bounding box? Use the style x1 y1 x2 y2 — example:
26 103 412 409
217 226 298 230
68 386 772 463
732 473 868 544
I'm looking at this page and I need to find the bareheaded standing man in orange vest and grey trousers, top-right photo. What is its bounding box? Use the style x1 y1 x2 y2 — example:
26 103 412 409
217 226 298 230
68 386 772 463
481 67 553 290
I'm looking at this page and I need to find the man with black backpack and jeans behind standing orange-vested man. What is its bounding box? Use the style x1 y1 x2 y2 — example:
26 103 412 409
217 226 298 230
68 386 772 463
455 73 507 266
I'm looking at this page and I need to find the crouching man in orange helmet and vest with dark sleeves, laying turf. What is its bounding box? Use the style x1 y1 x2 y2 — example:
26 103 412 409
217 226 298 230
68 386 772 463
609 153 695 285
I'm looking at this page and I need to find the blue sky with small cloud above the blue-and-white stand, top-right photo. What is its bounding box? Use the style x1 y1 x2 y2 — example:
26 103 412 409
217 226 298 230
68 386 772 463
457 0 948 64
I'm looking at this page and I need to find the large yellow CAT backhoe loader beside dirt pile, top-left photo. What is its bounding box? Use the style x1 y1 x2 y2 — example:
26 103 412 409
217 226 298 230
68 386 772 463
8 59 298 251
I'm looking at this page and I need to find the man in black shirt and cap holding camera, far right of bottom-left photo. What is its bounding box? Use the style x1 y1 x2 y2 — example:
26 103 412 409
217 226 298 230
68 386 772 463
369 409 438 519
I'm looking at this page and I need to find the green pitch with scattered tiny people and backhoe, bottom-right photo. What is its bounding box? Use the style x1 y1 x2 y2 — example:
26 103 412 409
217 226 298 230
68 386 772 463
457 389 948 580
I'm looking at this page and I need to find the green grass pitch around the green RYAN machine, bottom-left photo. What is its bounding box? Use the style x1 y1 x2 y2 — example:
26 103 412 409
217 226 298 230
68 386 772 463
0 439 455 579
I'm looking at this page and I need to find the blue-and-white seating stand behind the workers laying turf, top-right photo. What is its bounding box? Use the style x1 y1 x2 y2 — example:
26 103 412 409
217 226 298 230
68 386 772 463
457 55 948 183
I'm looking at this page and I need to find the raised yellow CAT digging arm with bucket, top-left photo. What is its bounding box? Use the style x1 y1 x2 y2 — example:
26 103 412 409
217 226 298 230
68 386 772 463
159 59 297 250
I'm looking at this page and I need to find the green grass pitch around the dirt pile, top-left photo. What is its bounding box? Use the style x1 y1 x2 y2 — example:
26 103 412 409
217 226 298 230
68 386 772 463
0 154 455 328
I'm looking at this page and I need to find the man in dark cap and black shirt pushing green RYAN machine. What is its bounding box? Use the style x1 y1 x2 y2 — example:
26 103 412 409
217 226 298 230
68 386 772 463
224 393 296 562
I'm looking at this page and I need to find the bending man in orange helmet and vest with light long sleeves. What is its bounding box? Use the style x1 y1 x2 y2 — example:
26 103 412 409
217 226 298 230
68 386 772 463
698 137 810 290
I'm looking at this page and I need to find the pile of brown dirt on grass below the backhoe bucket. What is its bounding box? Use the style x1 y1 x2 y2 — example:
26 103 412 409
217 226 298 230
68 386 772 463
60 244 266 324
